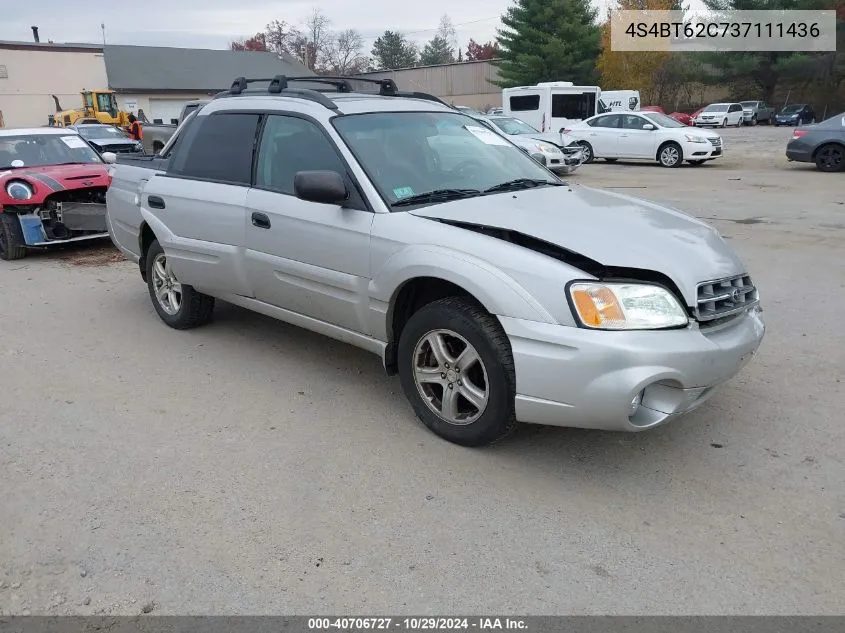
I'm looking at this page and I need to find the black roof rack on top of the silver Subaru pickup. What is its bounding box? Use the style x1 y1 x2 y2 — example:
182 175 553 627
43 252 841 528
213 75 449 110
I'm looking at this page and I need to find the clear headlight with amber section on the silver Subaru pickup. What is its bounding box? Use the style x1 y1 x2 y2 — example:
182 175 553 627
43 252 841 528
569 282 689 330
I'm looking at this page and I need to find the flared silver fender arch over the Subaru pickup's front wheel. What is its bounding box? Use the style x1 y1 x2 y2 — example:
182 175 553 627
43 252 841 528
369 245 557 341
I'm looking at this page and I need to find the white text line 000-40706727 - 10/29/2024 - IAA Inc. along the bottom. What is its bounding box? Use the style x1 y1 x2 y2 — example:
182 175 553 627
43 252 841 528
308 617 528 631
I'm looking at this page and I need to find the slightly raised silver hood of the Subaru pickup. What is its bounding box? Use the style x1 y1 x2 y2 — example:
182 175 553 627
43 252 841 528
410 186 746 306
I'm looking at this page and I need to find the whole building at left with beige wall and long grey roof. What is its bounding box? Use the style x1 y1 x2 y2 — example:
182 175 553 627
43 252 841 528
0 28 314 127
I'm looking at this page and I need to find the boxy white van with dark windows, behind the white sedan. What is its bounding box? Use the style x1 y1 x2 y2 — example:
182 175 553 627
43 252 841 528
502 81 606 132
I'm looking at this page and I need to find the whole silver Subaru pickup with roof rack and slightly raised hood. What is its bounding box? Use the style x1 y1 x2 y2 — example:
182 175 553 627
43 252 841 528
107 78 765 446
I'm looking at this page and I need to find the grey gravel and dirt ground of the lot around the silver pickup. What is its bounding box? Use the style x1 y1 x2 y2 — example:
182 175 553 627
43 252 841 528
0 127 845 615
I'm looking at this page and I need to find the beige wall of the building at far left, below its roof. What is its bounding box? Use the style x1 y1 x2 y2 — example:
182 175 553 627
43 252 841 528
0 45 108 128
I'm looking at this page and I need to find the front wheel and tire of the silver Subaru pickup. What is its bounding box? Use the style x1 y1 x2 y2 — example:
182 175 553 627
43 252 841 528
398 297 517 446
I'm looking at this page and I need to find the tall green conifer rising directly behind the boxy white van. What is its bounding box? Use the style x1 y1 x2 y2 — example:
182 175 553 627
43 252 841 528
497 0 601 88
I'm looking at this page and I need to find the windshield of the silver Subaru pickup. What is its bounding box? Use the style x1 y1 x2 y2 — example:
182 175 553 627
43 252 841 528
332 112 562 205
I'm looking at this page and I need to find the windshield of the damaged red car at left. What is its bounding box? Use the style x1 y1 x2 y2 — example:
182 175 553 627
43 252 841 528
0 134 103 169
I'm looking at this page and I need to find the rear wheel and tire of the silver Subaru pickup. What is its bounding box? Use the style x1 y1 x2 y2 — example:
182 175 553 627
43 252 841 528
146 240 214 330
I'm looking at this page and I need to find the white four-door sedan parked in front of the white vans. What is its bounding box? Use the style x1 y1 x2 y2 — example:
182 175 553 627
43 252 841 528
564 112 723 167
